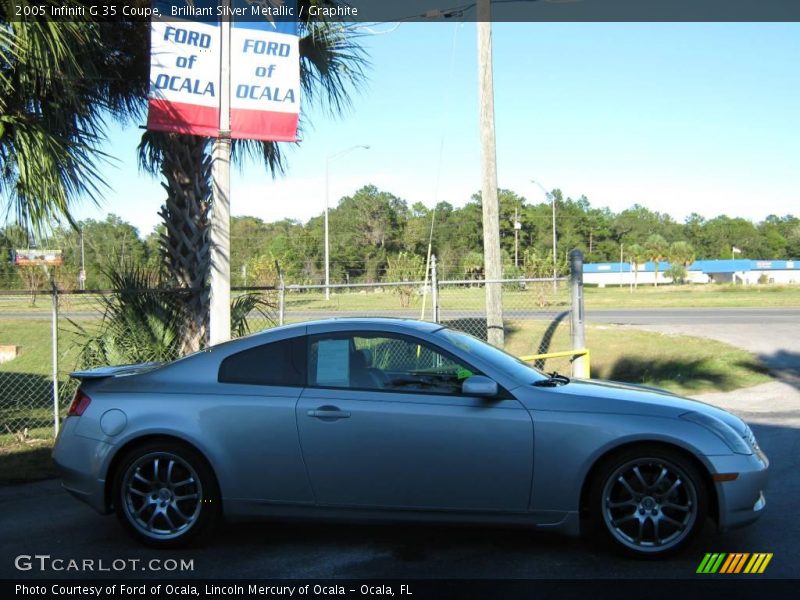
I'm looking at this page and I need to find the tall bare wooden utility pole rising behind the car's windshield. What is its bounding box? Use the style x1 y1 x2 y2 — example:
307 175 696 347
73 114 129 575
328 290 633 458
477 0 504 348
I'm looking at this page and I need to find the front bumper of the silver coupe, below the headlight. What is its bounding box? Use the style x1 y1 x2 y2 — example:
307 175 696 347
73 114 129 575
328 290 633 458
709 450 769 531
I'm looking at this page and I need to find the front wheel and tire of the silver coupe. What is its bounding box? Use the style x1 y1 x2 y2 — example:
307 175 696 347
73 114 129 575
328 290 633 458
589 446 708 558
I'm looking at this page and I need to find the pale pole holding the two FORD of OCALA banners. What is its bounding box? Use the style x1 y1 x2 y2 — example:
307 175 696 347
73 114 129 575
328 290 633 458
209 0 231 345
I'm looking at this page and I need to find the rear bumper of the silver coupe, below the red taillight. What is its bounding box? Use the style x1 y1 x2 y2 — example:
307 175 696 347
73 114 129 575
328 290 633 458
53 417 112 514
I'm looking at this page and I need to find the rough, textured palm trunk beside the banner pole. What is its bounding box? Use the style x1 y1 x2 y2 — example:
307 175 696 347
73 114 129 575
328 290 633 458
158 134 211 354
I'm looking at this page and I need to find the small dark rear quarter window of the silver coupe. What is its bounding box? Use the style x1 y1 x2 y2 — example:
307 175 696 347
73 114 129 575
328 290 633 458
218 337 306 386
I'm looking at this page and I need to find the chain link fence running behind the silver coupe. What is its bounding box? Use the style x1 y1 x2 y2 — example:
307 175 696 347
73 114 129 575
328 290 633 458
0 253 588 442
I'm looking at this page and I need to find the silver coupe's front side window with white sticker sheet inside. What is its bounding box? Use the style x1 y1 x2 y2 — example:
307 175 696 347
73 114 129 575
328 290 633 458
308 333 478 394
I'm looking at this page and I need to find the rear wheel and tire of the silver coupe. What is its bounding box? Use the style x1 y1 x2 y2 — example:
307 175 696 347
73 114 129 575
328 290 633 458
113 441 221 548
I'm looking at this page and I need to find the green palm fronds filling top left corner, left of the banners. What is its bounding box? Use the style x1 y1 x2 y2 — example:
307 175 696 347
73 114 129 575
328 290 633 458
0 6 149 231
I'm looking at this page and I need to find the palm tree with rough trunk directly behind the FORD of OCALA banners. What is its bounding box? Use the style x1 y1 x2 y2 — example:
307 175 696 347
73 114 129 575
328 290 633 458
139 17 366 352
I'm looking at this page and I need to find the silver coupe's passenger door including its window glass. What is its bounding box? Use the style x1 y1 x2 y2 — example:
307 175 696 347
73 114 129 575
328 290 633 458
297 332 533 511
